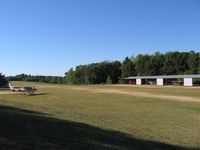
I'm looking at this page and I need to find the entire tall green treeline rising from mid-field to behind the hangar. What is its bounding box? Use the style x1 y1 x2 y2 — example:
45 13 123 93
64 51 200 84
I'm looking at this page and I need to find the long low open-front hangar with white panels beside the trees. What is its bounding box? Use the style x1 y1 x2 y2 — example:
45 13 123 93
125 74 200 86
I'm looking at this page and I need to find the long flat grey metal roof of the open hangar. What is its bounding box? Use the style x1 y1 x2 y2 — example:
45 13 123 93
125 74 200 80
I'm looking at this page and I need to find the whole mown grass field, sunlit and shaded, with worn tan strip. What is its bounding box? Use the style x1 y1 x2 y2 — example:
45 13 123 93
0 82 200 150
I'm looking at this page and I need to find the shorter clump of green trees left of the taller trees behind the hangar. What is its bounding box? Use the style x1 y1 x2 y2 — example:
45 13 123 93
65 61 121 84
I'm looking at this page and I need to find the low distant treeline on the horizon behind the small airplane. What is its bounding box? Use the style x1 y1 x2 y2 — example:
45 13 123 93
6 74 64 84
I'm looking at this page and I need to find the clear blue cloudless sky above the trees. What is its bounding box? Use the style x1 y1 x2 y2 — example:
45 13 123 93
0 0 200 76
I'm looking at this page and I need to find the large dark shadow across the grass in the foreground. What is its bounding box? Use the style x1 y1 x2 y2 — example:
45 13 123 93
0 106 197 150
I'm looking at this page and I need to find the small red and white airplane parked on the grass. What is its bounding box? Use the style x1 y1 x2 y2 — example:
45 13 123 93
9 83 38 95
